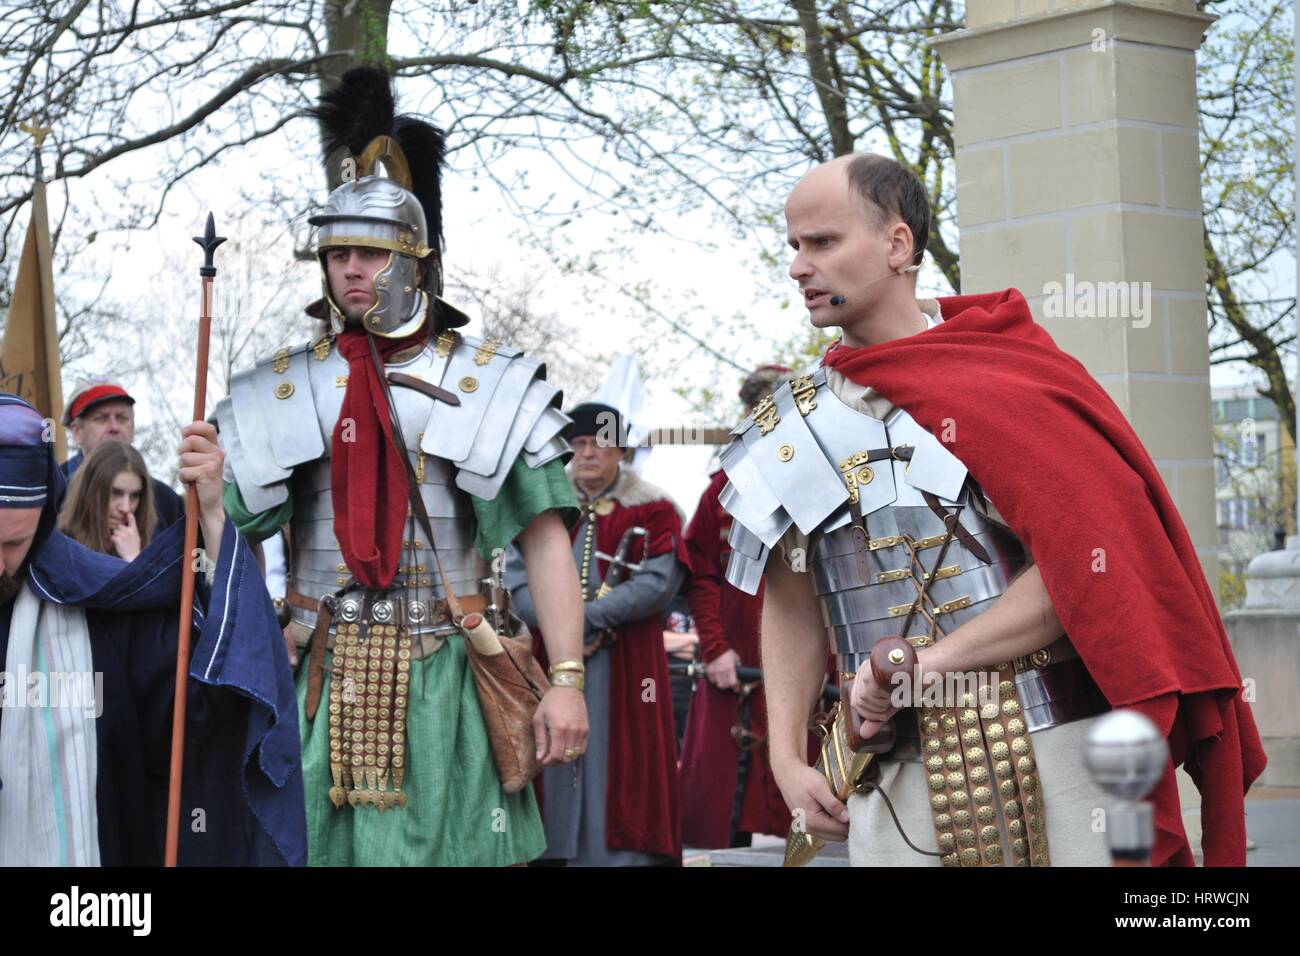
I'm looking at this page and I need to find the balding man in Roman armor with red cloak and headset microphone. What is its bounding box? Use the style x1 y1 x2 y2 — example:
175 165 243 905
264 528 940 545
719 155 1264 866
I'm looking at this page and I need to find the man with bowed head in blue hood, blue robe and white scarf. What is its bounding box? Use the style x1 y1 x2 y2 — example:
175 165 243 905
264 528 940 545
0 393 307 866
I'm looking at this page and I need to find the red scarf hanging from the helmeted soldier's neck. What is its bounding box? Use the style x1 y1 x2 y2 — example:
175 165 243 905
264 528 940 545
330 329 429 588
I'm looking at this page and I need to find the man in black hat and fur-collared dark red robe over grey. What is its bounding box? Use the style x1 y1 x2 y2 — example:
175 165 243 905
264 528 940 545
504 403 688 866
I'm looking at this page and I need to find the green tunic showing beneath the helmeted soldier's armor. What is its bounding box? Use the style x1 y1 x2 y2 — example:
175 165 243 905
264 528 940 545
225 459 580 866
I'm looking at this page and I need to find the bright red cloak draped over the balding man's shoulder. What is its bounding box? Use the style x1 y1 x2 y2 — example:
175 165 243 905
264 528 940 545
823 289 1266 866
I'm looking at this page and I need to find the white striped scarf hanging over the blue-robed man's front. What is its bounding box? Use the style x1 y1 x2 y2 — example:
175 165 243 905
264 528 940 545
0 581 101 866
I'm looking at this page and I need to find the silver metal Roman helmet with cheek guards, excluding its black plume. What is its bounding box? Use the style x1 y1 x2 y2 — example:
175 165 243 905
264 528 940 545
308 176 434 338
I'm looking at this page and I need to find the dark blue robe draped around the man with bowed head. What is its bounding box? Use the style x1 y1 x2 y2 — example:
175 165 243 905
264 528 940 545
0 519 307 866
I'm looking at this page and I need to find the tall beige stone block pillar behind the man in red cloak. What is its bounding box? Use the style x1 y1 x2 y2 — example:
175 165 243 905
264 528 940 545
932 0 1218 594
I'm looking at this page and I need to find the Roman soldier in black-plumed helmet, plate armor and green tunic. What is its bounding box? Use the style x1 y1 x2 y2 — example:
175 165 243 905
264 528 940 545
217 69 586 865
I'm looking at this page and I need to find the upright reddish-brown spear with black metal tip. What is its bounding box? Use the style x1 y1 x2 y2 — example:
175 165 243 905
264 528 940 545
164 212 226 866
